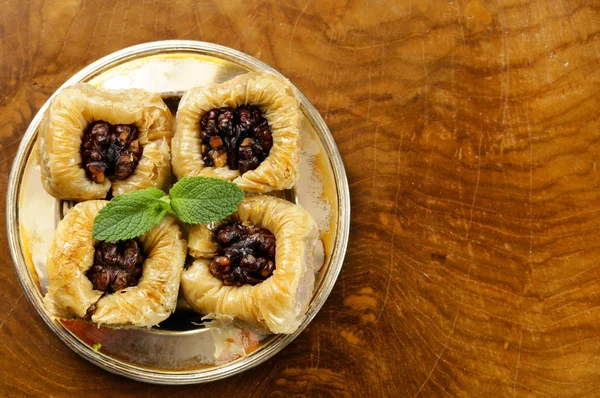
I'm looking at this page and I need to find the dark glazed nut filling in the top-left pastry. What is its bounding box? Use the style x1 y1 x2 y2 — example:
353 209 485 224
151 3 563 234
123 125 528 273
81 120 143 183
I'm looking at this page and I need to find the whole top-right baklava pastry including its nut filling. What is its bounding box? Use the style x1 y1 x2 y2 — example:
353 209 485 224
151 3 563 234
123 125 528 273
172 72 300 192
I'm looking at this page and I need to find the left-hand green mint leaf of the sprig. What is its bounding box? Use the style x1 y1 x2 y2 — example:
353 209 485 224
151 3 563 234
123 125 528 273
92 187 170 242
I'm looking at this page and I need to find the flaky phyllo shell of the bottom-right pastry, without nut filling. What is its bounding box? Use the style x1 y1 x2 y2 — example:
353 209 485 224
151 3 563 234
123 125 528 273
181 196 318 333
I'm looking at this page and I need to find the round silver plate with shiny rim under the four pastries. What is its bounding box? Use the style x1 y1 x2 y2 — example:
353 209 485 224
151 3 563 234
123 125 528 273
6 40 350 384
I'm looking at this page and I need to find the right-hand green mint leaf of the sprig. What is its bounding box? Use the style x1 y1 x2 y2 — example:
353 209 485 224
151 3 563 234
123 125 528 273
169 177 244 224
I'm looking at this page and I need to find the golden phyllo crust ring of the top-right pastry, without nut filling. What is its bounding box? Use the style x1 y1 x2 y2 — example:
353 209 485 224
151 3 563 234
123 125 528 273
172 72 300 193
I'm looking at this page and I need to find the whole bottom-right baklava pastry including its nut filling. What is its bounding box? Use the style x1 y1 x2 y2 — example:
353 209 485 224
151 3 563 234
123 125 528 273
181 196 318 333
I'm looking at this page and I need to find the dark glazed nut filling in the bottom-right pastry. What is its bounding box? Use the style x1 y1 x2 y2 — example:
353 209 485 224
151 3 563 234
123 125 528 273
209 222 275 286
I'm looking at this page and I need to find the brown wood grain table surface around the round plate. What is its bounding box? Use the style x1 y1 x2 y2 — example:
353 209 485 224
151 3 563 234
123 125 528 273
0 0 600 397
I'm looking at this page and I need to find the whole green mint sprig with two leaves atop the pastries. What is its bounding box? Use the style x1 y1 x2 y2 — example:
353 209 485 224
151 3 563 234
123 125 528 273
92 177 244 242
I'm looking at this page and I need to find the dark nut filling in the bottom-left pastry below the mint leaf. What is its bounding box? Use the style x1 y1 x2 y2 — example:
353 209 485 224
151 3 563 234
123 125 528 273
86 239 144 293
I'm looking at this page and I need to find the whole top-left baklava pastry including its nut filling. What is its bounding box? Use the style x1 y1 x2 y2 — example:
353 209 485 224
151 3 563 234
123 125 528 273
38 83 172 201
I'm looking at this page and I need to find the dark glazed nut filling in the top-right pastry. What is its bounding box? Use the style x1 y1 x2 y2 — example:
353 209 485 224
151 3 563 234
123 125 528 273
200 105 273 174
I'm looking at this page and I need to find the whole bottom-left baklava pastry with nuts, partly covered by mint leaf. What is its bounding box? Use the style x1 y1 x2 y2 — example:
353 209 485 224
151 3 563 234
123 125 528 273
44 200 187 327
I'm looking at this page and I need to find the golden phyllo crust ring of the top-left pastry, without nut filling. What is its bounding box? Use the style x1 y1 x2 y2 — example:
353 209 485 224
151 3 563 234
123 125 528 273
37 83 172 200
